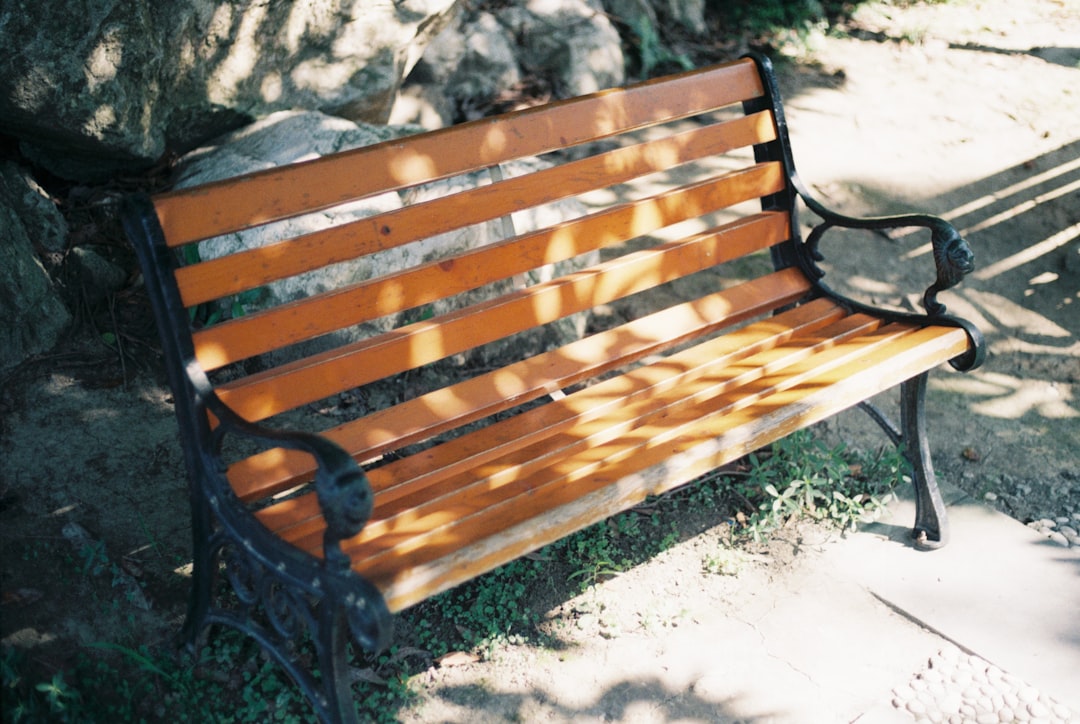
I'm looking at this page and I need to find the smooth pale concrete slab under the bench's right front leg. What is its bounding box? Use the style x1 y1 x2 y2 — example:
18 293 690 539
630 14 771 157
820 491 1080 722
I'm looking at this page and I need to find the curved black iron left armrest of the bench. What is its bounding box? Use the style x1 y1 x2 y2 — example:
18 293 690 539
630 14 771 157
203 391 375 571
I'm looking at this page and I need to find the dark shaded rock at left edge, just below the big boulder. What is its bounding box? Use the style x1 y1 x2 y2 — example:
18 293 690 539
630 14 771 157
0 162 71 371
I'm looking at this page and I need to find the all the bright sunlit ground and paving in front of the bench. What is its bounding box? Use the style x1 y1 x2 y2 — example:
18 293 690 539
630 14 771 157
405 479 1080 724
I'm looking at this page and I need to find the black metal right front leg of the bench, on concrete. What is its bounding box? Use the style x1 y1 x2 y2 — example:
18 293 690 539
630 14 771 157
900 372 948 550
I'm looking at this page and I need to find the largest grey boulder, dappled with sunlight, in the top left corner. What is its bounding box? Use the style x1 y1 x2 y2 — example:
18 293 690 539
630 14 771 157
0 0 456 179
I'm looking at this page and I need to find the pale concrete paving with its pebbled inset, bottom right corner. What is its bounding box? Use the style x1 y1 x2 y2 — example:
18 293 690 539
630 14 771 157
821 491 1080 722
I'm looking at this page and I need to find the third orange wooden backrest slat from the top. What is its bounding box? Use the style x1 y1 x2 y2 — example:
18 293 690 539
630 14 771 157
194 162 784 369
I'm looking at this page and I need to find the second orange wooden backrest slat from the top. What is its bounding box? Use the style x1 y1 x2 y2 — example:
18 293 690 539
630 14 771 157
170 112 775 307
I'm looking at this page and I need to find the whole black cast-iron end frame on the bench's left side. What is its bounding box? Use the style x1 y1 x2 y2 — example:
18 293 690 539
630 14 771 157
123 195 393 722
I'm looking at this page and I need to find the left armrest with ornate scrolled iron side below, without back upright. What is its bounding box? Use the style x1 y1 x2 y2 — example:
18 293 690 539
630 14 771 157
194 392 392 721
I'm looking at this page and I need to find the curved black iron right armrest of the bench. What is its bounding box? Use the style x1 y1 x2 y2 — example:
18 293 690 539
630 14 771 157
792 176 975 317
